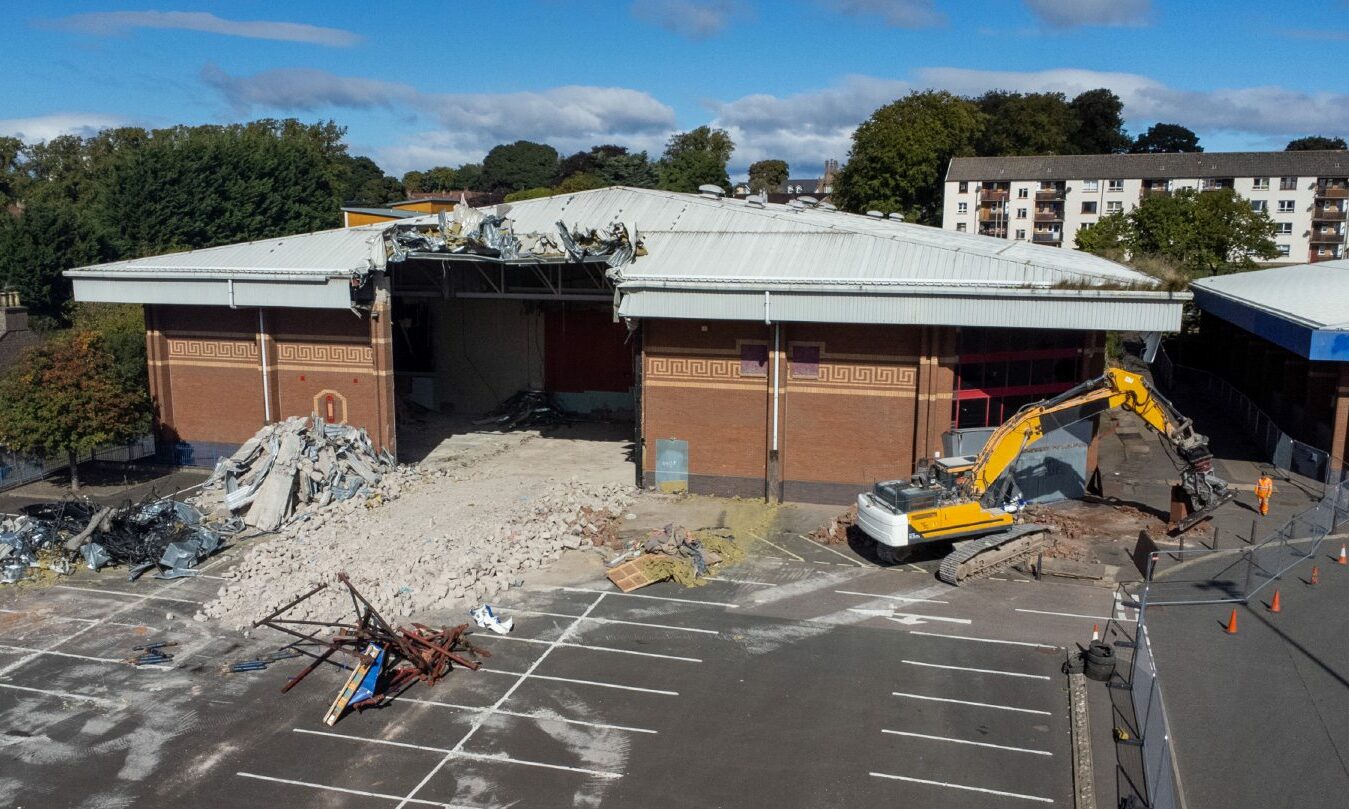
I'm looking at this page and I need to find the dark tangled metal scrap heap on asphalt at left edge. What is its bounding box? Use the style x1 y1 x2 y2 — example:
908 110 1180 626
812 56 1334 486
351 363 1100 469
0 499 243 582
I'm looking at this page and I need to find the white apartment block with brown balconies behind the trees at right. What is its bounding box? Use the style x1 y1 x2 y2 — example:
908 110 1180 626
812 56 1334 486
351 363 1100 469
942 151 1349 264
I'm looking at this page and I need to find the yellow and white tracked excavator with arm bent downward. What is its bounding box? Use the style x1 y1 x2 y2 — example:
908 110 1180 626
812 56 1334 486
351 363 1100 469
857 368 1236 585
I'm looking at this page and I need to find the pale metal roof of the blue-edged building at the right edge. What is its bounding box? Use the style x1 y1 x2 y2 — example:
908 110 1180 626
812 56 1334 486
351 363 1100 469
1194 259 1349 330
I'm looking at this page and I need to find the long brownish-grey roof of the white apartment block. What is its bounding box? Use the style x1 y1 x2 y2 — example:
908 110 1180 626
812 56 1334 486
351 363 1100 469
946 150 1349 182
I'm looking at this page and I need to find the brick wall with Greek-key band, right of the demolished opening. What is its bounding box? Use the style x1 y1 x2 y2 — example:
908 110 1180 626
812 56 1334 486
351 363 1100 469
641 320 1103 503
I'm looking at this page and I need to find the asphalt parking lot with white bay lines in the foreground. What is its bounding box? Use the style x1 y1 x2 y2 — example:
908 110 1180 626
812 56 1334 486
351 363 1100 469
0 509 1129 809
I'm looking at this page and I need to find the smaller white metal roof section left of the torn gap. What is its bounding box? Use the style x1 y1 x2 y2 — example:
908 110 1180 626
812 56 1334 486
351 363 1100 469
66 224 389 280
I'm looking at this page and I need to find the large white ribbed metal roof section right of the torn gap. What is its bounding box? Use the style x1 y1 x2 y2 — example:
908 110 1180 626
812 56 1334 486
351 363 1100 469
403 187 1153 287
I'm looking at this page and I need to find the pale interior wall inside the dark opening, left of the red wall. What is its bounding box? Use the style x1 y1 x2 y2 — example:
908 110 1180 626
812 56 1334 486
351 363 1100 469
428 298 545 414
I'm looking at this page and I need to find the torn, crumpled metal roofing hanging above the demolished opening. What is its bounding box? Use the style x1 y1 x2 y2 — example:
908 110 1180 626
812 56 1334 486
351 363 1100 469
389 205 646 267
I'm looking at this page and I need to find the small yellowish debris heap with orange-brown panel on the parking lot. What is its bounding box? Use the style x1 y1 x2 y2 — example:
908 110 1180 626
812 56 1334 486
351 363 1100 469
608 525 745 593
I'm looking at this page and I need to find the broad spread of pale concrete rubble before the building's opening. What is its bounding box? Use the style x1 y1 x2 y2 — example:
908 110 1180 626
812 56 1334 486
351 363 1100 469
198 479 633 630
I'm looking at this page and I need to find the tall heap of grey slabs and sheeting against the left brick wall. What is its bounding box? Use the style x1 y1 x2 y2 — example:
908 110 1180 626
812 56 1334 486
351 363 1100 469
192 417 398 531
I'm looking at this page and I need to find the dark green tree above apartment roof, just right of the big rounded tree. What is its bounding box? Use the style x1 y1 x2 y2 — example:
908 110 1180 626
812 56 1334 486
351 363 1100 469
975 90 1078 156
